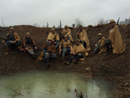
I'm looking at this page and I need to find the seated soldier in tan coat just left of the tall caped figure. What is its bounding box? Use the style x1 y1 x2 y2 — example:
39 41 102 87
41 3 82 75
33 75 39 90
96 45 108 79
91 33 106 56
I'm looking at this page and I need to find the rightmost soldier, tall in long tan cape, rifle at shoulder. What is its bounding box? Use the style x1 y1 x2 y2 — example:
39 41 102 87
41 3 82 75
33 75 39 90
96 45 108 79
106 19 125 54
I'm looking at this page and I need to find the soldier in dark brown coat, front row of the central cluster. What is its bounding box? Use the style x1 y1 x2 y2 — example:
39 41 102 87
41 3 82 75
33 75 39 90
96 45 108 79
36 39 57 67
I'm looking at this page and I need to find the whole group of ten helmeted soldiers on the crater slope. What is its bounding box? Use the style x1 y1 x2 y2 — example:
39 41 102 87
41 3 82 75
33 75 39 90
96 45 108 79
3 20 125 67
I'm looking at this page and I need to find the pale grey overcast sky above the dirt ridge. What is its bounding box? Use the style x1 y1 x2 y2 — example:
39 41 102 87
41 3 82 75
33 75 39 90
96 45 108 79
0 0 130 27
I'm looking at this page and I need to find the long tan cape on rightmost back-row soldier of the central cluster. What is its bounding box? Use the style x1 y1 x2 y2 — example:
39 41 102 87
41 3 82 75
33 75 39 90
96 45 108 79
76 29 90 51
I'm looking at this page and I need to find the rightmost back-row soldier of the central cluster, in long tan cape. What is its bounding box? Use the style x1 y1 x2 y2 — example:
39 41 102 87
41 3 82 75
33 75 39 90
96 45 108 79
76 25 90 51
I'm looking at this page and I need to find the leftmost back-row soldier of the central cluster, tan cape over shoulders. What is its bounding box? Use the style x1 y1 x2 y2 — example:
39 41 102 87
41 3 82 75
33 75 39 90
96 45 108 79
47 28 59 49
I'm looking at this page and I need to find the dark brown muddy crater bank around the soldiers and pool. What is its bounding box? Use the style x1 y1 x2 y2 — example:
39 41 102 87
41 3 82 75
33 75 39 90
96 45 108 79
0 25 130 98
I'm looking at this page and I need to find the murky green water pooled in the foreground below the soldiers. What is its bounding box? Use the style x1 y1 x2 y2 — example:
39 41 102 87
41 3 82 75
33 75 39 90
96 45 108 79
0 71 112 98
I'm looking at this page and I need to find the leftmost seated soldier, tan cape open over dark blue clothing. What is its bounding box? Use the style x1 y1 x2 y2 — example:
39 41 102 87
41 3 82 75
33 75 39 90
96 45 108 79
4 27 21 51
